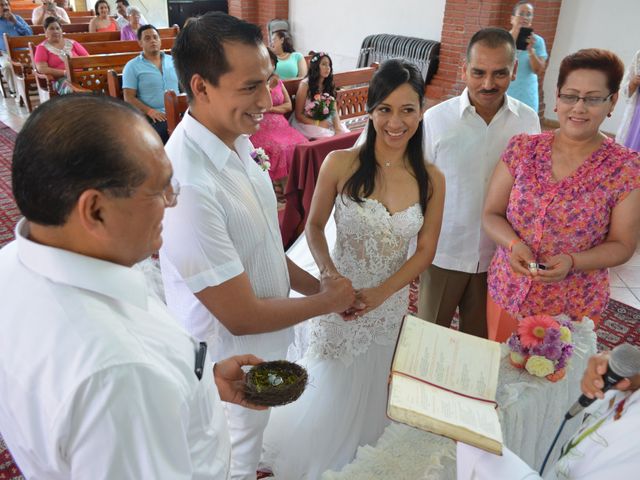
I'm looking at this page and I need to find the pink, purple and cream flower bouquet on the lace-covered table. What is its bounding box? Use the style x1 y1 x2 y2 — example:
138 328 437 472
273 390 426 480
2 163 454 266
507 315 573 382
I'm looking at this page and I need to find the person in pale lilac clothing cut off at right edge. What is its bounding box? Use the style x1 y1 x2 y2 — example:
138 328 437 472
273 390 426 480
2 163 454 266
616 50 640 152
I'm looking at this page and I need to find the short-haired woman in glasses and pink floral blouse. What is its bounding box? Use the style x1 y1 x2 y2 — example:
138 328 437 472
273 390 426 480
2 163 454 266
483 49 640 341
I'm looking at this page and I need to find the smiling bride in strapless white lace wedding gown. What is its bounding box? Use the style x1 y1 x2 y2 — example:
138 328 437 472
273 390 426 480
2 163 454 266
262 59 444 480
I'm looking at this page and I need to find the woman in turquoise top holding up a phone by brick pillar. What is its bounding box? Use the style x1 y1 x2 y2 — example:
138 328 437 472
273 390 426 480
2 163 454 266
507 1 549 112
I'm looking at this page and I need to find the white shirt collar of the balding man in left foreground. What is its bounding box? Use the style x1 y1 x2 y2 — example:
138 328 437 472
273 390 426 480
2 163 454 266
15 218 147 310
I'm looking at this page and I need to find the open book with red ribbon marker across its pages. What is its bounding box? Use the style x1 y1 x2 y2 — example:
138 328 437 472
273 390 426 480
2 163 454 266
387 315 502 455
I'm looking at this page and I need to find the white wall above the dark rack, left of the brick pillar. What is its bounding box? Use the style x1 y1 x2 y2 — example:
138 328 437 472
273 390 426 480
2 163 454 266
289 0 446 72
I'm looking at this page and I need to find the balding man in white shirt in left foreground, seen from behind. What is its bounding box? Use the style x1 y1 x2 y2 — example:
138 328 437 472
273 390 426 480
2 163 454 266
0 95 260 480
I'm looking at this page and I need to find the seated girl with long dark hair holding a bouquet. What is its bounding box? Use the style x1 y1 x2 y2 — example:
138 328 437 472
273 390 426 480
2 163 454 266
291 52 347 139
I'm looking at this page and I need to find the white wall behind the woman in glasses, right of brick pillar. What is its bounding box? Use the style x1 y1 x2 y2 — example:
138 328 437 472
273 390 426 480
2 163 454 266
534 0 640 133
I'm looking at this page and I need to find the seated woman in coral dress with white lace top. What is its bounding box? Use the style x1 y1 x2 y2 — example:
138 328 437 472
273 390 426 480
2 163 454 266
34 17 89 95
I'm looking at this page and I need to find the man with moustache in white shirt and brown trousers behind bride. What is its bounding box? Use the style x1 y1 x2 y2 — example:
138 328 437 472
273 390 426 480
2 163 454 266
418 28 540 337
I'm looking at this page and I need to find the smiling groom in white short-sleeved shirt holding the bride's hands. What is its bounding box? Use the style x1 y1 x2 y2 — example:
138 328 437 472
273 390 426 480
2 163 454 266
160 13 356 480
